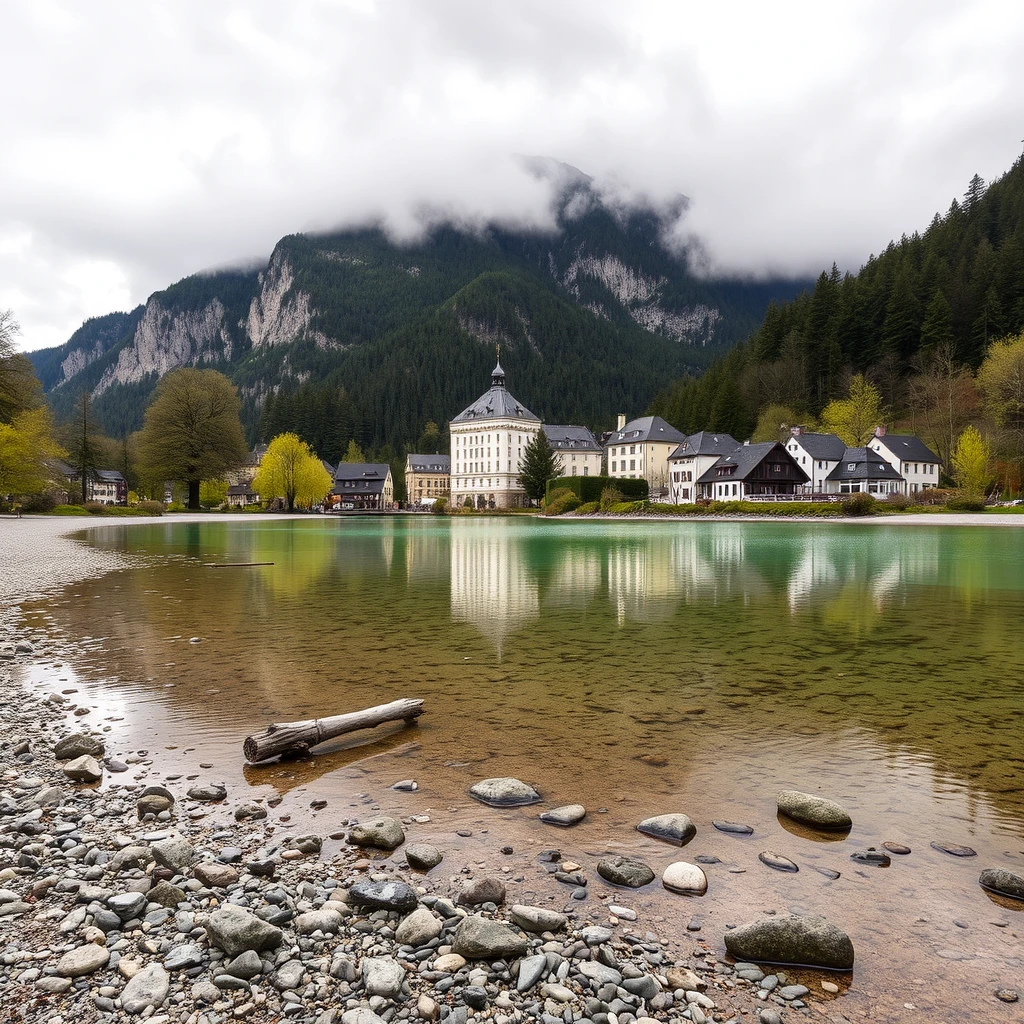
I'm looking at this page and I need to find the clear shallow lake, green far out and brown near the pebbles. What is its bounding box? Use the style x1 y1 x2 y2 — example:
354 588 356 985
19 516 1024 1020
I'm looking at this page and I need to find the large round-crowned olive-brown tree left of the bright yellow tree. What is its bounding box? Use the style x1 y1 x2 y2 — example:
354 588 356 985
139 368 248 509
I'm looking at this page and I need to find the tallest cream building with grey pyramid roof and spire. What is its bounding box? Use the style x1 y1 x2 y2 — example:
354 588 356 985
449 362 541 509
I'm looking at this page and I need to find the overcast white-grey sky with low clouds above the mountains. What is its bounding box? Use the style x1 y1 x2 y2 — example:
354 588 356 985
0 0 1024 349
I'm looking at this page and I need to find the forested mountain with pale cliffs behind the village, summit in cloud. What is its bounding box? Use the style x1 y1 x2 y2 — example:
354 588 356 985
31 162 807 459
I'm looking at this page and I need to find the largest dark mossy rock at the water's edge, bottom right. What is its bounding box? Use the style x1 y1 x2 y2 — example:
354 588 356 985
725 916 853 971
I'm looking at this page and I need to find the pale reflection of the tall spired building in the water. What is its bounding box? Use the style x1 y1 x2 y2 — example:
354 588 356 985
451 519 541 656
